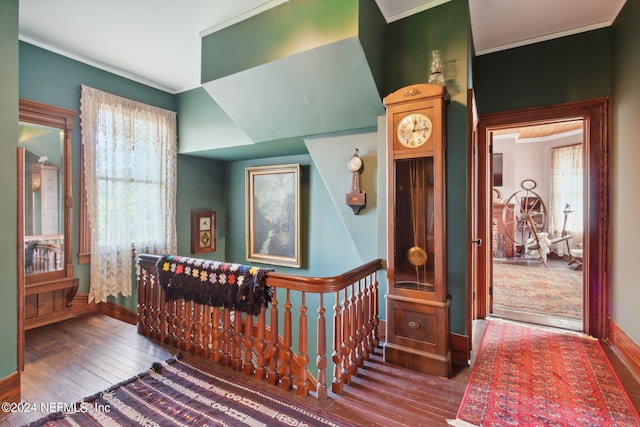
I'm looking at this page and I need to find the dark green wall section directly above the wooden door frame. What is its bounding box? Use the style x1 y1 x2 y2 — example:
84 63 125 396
473 28 613 114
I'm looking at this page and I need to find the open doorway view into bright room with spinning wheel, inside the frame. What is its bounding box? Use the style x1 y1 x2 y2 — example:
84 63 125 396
489 119 585 331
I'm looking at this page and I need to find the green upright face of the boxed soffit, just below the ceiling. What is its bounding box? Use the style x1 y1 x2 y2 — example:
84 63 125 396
201 0 358 83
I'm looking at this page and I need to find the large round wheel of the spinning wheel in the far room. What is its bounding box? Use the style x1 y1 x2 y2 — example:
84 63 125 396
502 190 547 246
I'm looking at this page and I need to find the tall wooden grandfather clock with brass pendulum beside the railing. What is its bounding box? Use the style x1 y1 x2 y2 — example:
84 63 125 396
384 84 451 377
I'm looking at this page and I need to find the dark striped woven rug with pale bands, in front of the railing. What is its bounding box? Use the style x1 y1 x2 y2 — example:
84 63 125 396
29 356 348 427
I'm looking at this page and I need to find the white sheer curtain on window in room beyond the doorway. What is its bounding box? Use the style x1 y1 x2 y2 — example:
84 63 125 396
549 144 584 256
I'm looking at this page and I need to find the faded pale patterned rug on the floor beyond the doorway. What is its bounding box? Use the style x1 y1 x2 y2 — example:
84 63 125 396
493 262 583 320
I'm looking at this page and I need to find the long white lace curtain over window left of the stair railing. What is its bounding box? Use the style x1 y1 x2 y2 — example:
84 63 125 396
80 86 177 302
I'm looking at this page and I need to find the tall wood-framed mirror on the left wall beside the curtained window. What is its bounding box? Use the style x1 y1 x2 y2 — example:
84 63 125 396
18 99 76 284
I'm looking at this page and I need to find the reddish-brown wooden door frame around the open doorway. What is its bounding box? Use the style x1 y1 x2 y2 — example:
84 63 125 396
471 98 610 338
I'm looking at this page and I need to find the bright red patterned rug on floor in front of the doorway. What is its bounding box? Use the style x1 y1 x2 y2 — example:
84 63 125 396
449 320 640 427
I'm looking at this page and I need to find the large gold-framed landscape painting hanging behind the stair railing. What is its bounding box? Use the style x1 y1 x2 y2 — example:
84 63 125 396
245 164 301 268
